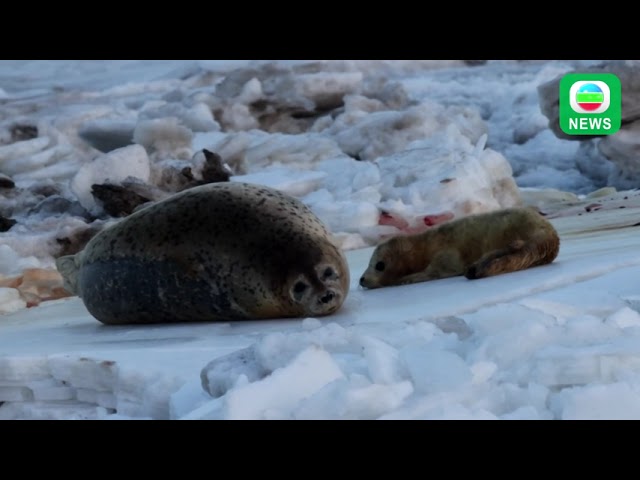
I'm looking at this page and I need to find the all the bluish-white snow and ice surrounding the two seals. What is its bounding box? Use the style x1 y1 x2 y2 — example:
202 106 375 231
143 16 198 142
0 60 640 420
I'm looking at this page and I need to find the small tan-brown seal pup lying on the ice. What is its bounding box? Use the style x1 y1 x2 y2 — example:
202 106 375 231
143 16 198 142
360 208 560 288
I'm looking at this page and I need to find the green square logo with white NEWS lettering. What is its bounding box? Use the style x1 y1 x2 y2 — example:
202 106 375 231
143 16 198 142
560 73 622 135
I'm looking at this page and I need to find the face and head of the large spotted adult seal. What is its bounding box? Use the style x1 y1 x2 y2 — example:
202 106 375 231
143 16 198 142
285 244 349 316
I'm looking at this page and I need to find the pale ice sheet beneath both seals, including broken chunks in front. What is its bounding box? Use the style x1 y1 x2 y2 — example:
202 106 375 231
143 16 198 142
0 209 640 419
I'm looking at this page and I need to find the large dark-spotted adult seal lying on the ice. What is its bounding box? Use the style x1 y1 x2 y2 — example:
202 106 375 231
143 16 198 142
57 182 349 324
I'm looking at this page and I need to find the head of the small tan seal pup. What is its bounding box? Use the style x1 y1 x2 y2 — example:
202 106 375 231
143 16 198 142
360 236 414 288
